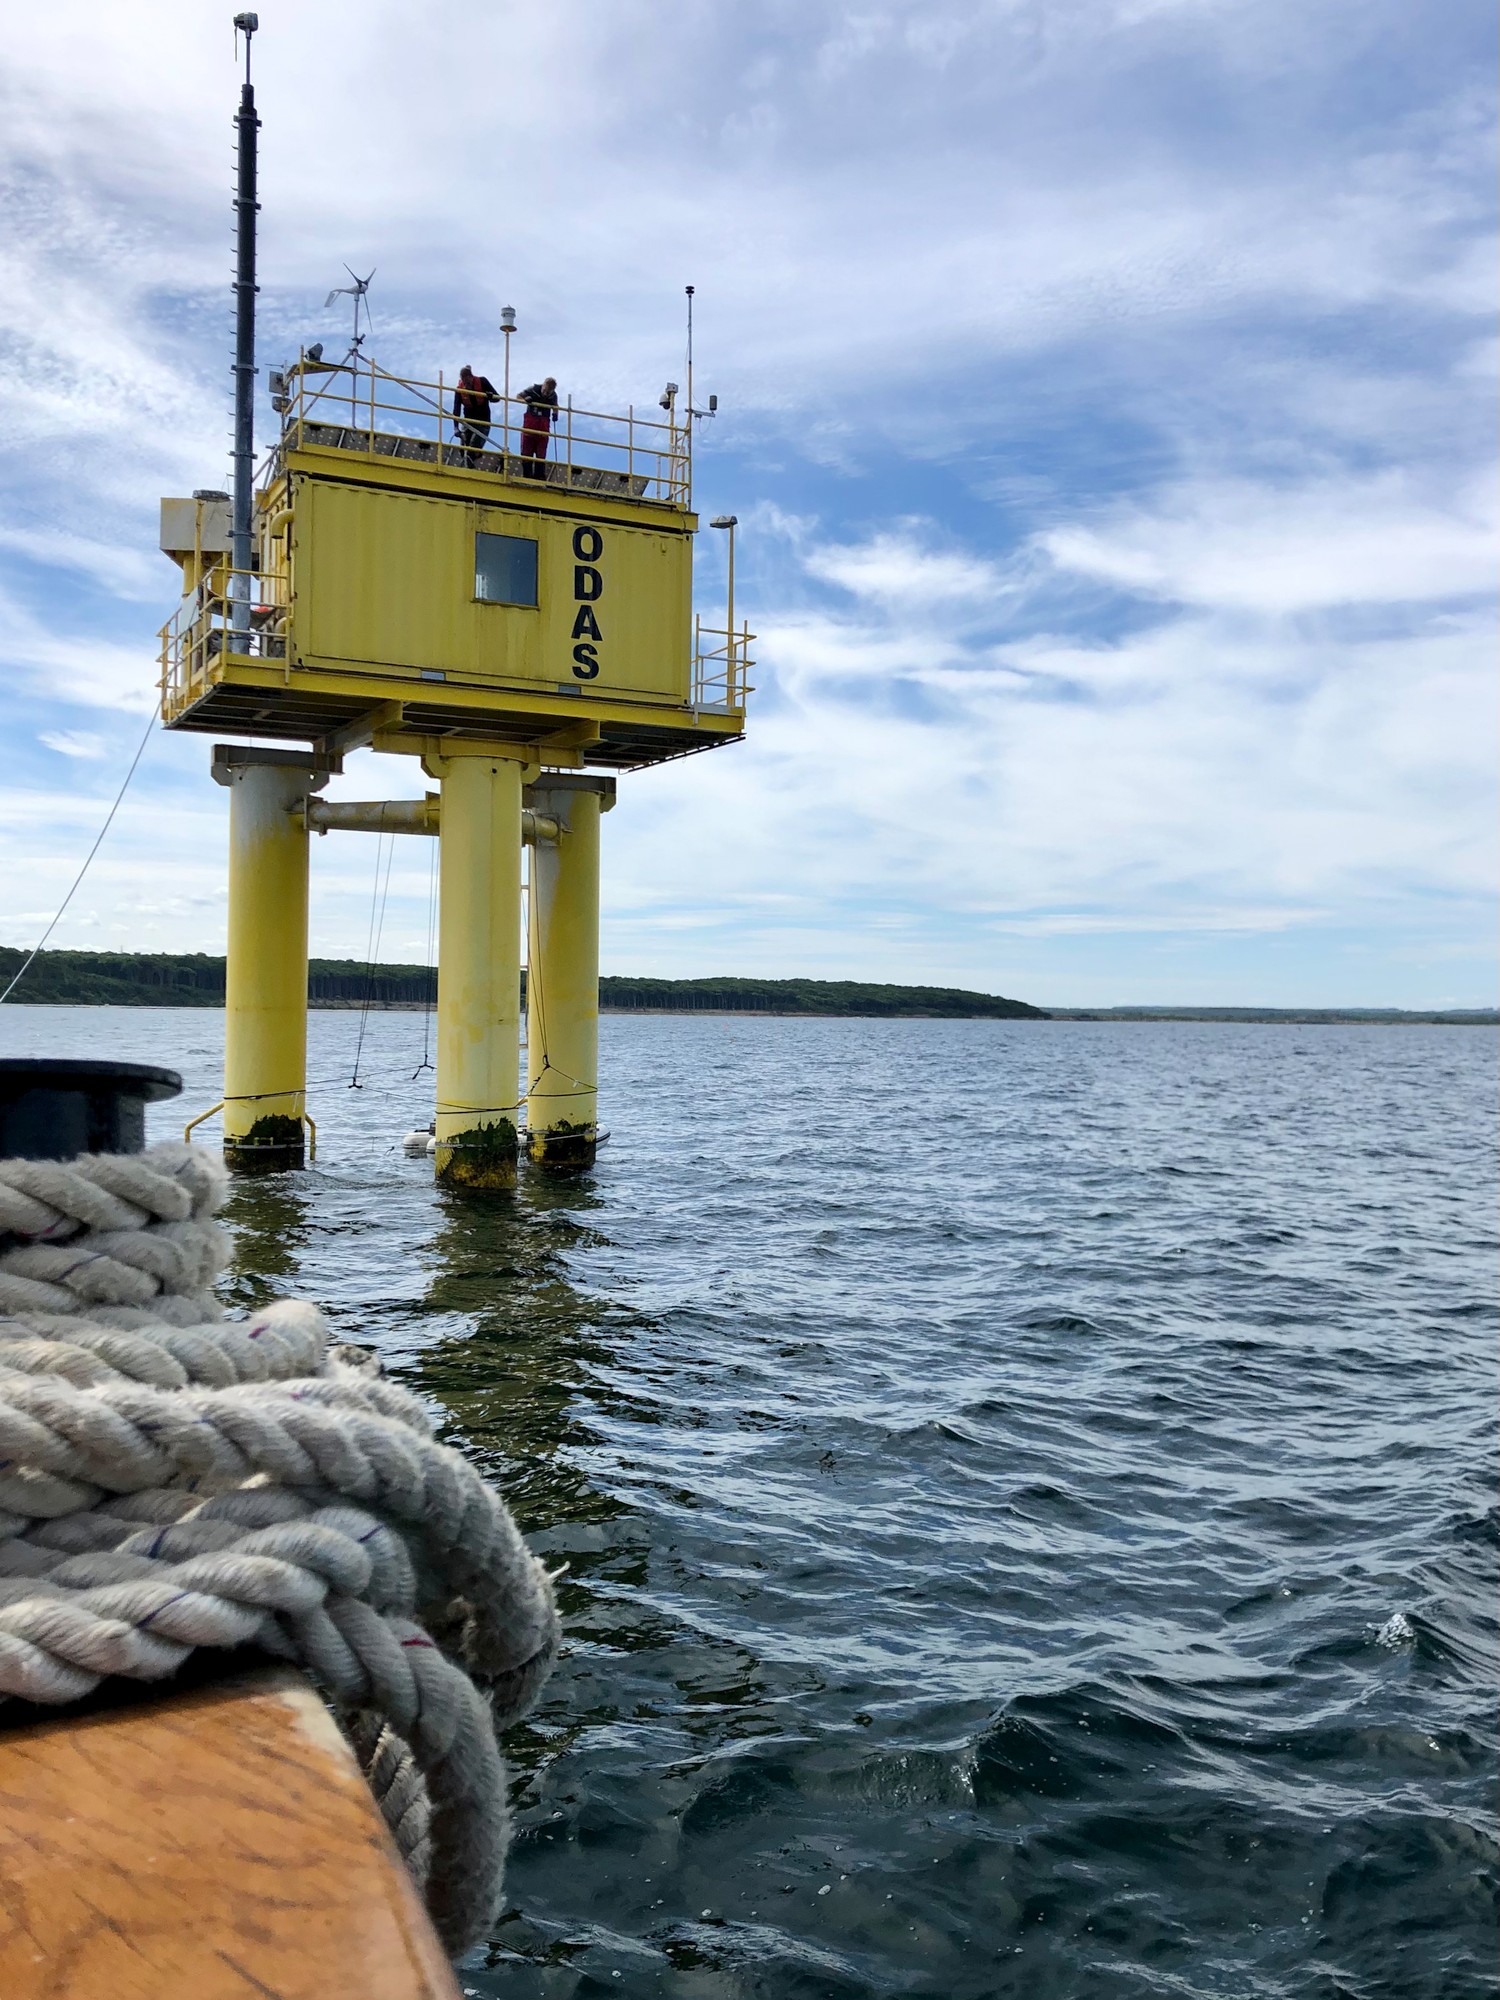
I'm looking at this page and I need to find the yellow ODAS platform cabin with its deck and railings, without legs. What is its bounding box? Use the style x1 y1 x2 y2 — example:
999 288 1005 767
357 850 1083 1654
162 356 750 770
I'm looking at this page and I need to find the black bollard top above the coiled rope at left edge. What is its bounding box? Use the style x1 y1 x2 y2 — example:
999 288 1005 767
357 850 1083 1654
0 1056 182 1160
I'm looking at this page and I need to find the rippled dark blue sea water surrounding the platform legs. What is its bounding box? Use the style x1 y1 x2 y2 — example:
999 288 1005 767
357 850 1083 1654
4 1008 1496 2000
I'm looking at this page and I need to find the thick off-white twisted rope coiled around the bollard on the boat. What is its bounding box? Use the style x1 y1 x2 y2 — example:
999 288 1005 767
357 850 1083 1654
0 1144 558 1954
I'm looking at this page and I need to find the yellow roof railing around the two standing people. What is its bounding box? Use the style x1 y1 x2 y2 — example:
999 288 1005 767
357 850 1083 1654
258 354 692 508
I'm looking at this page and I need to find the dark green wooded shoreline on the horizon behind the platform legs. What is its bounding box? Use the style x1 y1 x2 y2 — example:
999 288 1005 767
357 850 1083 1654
0 946 1048 1020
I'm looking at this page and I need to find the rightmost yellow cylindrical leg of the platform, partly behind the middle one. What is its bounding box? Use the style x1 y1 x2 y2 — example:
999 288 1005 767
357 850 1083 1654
526 778 608 1168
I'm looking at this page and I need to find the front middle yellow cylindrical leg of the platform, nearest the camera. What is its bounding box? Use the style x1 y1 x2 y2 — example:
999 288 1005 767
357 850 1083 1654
426 744 534 1188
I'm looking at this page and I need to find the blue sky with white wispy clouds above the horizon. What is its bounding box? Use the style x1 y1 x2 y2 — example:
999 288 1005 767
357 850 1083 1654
0 0 1496 1006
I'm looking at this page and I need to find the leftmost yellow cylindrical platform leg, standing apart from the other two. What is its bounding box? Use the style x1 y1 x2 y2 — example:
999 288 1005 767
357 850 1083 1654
214 750 326 1172
